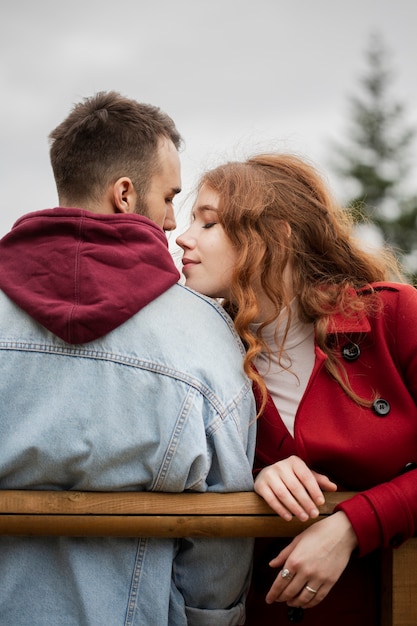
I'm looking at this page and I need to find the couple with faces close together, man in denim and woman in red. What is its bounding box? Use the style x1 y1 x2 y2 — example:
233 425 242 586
0 93 417 626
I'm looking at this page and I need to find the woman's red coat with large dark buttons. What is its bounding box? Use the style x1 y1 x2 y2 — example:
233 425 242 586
246 283 417 626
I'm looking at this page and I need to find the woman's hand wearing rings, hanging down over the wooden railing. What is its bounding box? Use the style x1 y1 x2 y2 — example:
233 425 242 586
266 511 357 608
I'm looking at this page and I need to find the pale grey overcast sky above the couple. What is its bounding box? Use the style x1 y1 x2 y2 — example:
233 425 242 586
0 0 417 246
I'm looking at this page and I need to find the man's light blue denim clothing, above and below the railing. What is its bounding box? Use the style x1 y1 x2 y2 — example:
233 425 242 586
0 285 256 626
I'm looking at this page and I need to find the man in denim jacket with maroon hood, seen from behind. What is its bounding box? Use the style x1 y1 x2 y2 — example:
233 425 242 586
0 92 256 626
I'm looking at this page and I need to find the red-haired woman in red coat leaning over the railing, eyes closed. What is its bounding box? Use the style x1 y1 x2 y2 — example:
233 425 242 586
177 154 417 626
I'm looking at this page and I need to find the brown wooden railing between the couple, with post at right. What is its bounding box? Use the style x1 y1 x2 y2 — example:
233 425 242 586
0 490 417 626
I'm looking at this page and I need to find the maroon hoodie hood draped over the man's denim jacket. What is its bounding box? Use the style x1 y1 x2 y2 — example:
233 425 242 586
0 208 179 344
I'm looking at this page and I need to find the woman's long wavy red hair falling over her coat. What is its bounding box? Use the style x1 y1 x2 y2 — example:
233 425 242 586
199 153 400 410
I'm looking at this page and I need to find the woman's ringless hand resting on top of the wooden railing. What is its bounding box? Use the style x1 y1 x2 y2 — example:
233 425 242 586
255 456 337 522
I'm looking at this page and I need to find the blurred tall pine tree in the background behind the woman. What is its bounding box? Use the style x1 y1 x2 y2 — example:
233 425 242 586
333 34 417 278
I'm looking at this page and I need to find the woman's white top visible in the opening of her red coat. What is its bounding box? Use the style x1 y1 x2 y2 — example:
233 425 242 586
251 298 315 436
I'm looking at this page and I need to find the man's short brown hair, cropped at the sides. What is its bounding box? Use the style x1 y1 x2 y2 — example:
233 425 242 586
49 91 182 205
